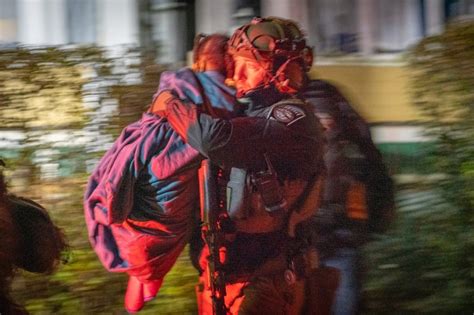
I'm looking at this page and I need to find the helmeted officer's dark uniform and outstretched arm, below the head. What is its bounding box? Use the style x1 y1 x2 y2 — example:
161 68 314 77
166 90 323 314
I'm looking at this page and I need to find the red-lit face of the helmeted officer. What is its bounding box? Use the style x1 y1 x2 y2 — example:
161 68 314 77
233 56 271 96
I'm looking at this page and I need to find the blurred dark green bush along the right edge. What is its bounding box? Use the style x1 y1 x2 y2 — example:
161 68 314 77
365 22 474 314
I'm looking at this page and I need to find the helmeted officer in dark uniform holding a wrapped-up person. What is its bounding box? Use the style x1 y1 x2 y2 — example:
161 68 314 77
159 18 323 314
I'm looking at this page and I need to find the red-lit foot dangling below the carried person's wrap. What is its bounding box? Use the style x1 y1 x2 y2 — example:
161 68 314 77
125 276 163 314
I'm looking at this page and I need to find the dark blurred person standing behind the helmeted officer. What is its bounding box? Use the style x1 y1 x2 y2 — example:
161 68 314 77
302 80 394 315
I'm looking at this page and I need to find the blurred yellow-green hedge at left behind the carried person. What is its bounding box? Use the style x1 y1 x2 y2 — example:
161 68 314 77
0 47 197 314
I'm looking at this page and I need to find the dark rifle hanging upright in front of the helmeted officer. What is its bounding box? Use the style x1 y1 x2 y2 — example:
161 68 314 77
199 160 227 315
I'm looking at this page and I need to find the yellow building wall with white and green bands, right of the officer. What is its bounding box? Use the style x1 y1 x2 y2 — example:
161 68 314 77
310 63 431 174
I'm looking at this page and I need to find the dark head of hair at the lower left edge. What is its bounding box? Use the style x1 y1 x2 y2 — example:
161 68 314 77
0 160 67 314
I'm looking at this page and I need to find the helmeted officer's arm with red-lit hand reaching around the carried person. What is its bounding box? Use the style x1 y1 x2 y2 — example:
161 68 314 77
157 92 320 168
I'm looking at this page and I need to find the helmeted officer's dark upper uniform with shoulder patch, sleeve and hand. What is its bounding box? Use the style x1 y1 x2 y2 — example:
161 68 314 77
167 91 322 179
